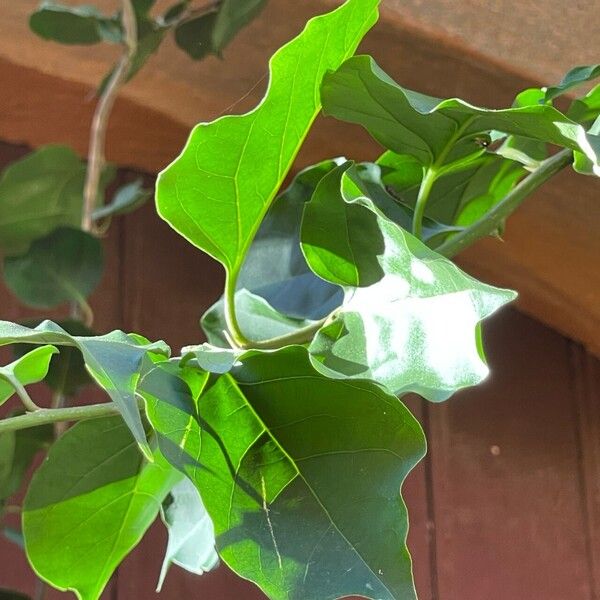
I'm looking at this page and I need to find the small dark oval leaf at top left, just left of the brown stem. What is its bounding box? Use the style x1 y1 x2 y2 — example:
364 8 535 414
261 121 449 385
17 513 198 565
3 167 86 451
29 0 122 44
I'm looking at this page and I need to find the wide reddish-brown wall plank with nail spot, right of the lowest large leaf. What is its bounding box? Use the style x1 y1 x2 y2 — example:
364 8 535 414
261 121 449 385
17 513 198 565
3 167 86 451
431 310 592 600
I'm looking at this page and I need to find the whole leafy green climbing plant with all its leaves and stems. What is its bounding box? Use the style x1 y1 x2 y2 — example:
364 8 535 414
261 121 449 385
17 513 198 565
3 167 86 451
0 0 600 600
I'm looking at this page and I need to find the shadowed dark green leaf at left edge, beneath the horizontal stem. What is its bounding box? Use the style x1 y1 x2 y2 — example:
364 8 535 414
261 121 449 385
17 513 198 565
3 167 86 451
0 425 54 505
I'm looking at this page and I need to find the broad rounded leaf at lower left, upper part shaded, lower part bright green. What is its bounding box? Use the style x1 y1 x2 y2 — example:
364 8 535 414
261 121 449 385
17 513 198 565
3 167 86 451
23 417 180 600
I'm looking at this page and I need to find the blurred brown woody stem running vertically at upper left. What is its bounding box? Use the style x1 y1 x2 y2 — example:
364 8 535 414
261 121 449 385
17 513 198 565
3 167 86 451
81 0 137 231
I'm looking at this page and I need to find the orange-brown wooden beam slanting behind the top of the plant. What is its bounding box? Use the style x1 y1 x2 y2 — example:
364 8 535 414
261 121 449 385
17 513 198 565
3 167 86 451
0 0 600 354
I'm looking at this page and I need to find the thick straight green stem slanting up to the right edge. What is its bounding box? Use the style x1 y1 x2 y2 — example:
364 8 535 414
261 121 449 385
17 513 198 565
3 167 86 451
435 148 573 257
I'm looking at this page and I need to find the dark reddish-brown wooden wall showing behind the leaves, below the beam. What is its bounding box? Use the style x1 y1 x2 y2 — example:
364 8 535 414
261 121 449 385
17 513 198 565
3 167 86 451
0 145 600 600
